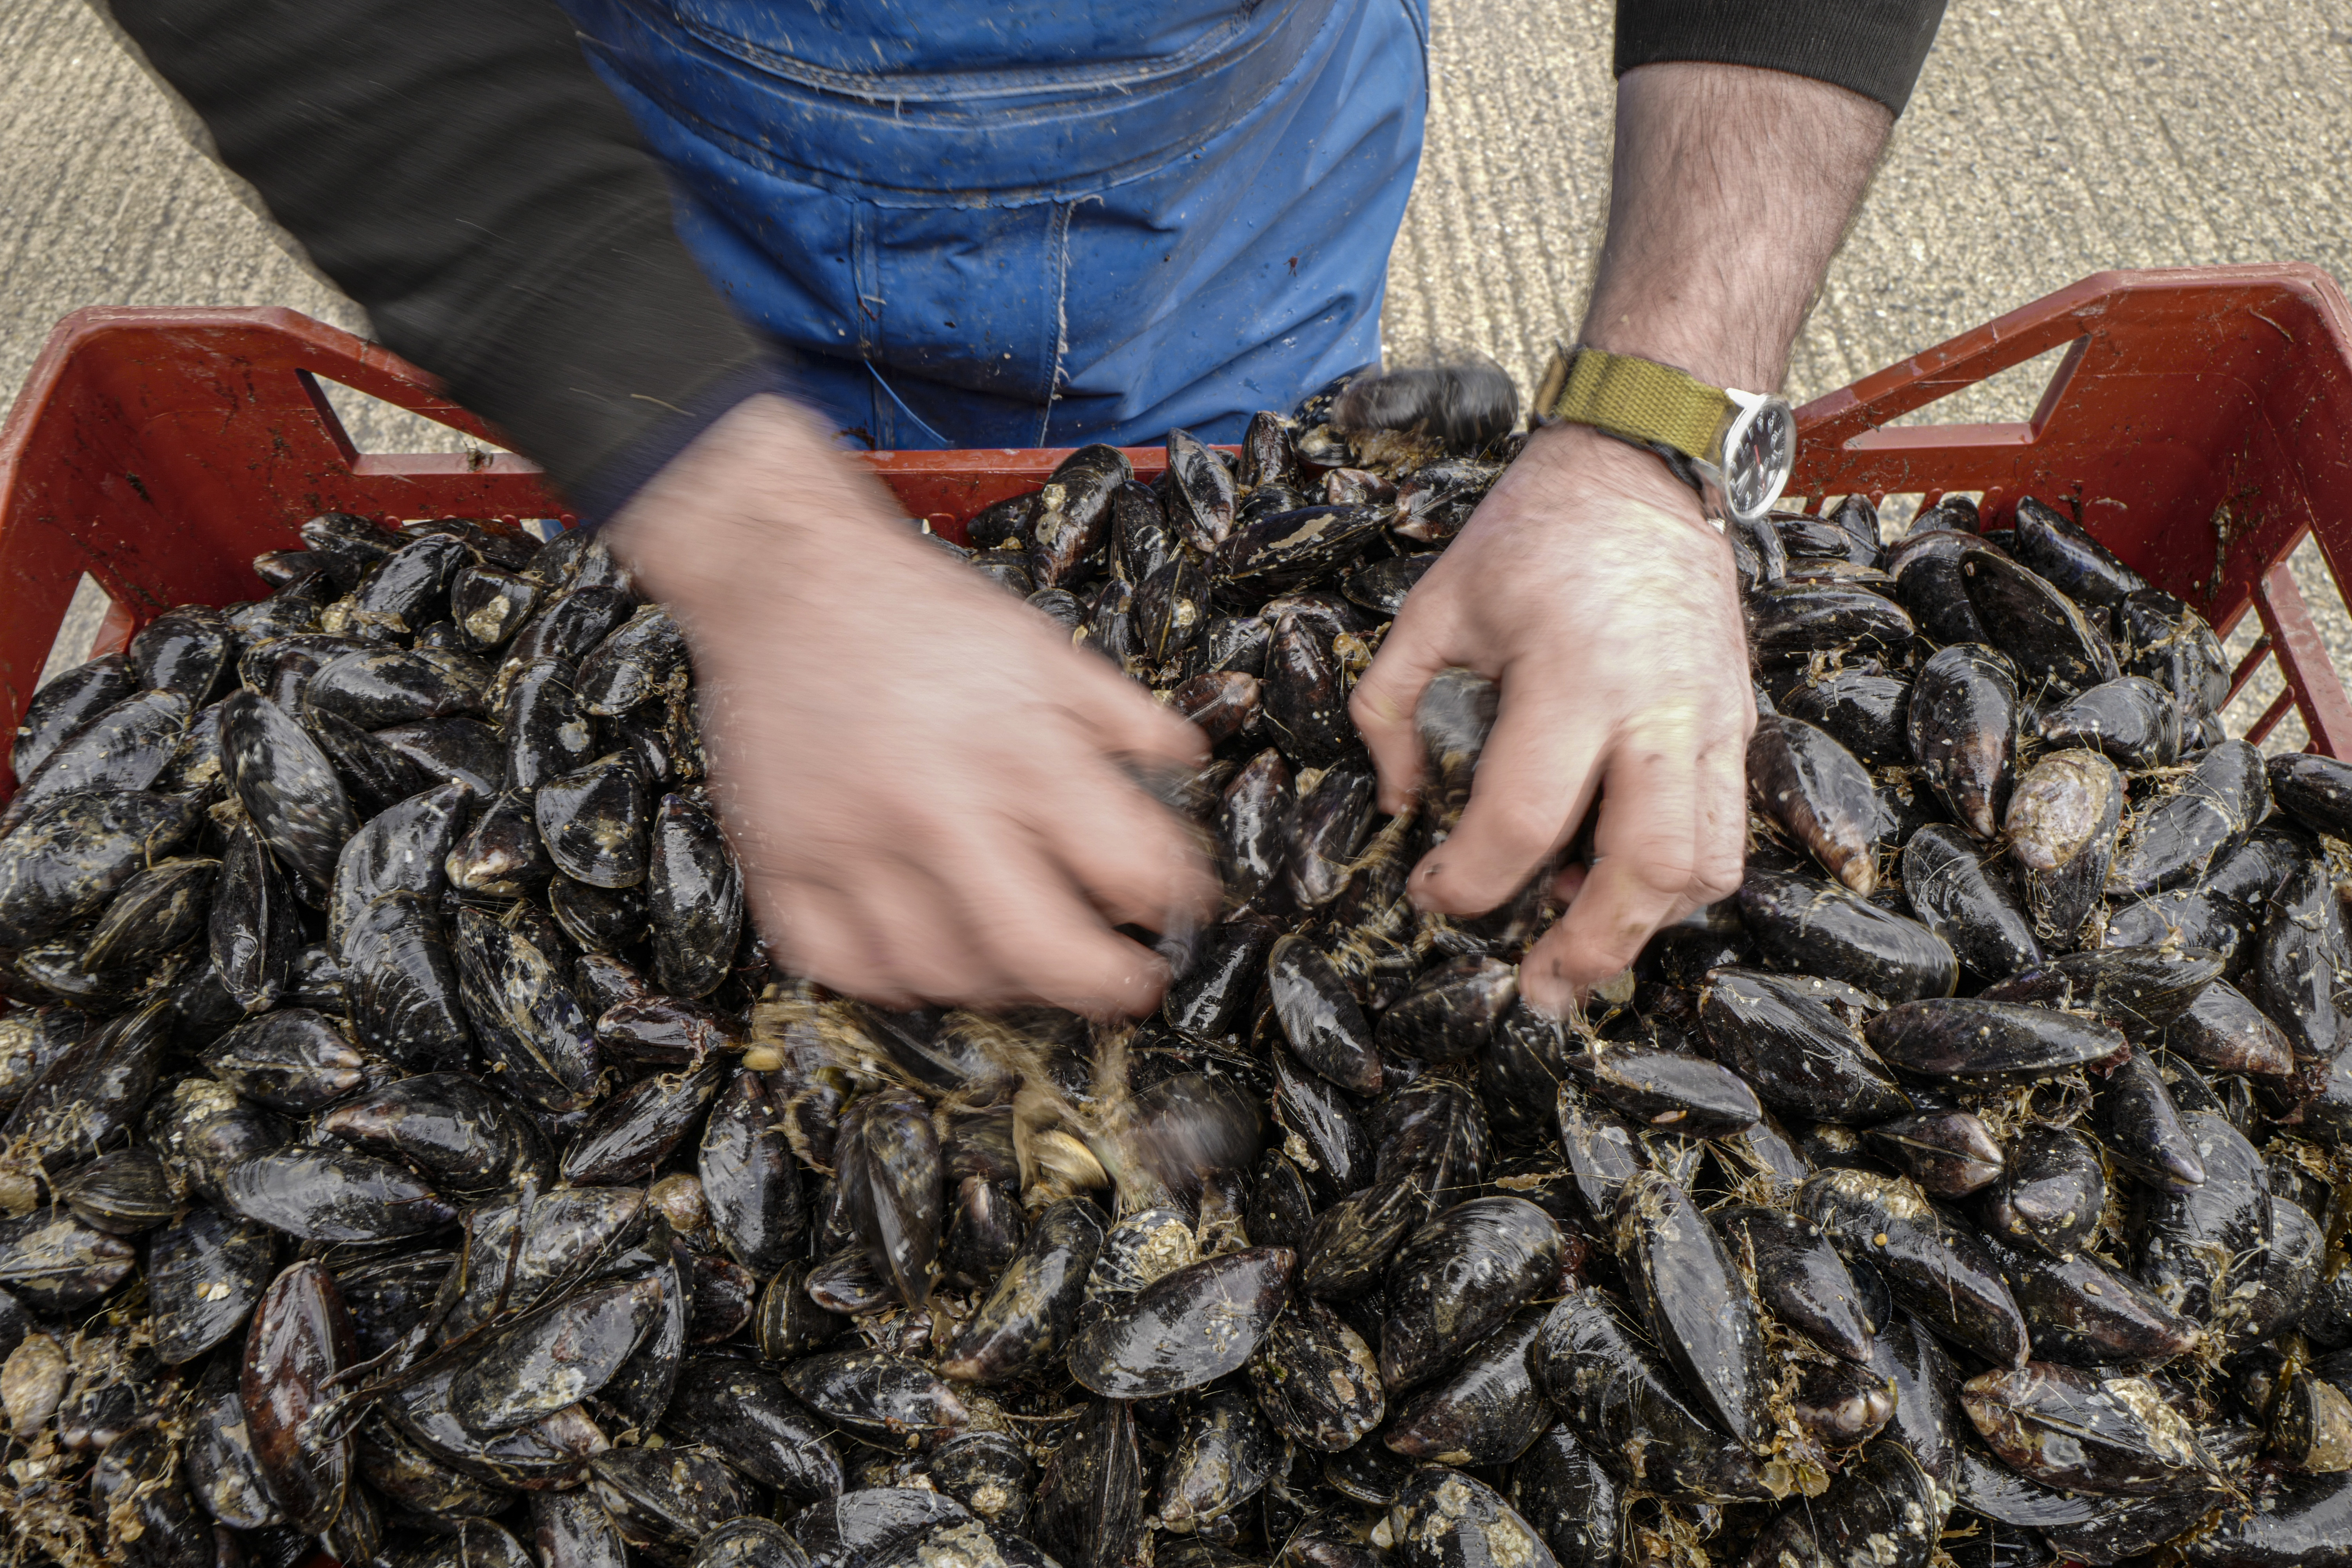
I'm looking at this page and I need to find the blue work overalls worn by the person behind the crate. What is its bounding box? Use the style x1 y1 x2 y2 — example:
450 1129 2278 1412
562 0 1428 446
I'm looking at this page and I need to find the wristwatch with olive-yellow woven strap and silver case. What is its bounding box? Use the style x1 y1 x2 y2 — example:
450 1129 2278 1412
1536 348 1797 524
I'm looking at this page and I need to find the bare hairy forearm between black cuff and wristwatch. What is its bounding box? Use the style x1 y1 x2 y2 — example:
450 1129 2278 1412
1581 61 1893 390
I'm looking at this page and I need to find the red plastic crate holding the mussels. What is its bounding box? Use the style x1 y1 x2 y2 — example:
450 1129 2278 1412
0 266 2352 797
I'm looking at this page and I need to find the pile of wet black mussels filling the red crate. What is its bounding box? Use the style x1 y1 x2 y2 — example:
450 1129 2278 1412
0 379 2352 1568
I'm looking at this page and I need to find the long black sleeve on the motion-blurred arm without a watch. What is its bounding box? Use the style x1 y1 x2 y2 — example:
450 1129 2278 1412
101 0 781 510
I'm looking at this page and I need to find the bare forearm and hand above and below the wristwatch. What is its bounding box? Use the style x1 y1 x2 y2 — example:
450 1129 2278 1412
1352 64 1893 1013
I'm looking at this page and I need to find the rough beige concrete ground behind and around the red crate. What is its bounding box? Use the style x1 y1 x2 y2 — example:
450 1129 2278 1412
0 0 2352 745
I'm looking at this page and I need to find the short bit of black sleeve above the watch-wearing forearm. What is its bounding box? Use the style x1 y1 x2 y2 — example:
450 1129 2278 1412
1616 0 1943 115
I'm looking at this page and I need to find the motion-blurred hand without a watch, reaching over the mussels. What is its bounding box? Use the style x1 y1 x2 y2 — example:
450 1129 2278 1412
609 397 1216 1016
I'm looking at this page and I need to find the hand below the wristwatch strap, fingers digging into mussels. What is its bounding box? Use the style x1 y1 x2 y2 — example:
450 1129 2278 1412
1352 428 1757 1013
